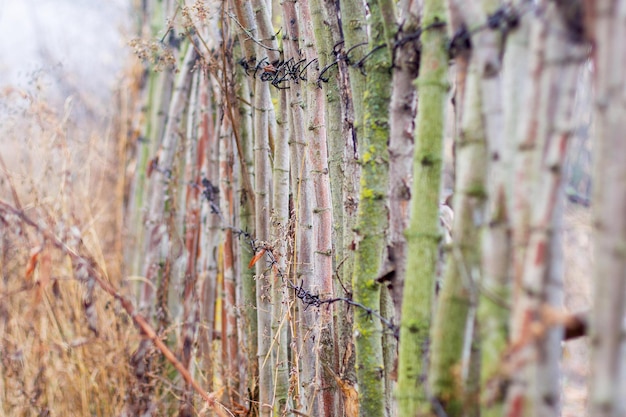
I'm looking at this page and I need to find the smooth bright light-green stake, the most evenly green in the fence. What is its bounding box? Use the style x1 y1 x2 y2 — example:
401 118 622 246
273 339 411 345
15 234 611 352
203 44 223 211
397 0 448 416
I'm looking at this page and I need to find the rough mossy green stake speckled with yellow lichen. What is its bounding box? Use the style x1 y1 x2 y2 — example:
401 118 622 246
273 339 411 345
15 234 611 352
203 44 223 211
352 2 393 417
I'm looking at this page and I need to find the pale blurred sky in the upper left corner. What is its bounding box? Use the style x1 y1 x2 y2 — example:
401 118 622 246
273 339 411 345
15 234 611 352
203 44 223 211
0 0 132 112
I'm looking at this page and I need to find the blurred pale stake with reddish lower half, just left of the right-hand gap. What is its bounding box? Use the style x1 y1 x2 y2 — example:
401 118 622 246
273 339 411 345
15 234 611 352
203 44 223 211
500 5 584 416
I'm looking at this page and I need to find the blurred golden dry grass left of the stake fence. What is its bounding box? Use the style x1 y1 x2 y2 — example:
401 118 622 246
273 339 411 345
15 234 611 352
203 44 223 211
0 74 140 416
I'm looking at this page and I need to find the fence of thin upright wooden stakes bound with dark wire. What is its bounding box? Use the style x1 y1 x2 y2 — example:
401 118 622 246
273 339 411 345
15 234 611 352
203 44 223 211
119 0 625 417
